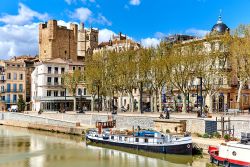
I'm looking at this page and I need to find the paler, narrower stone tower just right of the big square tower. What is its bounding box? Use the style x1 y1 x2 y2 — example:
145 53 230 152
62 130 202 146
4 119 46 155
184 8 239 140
77 23 99 60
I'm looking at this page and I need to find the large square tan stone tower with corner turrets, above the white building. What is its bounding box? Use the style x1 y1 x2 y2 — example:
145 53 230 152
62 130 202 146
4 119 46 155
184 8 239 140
39 20 78 61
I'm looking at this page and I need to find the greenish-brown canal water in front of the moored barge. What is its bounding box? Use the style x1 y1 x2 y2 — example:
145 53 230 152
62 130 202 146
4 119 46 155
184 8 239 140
0 126 210 167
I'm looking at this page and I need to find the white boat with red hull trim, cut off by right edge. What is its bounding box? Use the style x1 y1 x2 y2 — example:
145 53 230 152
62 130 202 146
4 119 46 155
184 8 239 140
208 133 250 167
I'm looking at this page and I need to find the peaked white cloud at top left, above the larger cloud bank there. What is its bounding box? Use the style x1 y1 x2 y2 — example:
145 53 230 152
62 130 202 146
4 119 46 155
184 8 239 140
0 3 49 25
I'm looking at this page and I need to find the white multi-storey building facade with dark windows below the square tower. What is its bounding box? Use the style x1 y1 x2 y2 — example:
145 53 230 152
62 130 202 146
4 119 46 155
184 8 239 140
31 58 90 111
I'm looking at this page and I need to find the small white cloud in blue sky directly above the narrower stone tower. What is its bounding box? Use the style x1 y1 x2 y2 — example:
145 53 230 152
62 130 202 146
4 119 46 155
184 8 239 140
71 7 92 22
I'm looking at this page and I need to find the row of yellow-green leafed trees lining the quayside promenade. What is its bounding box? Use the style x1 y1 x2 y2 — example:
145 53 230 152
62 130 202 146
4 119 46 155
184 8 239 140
59 25 250 113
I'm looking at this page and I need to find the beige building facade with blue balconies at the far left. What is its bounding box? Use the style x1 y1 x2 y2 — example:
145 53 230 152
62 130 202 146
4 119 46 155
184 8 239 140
0 56 37 111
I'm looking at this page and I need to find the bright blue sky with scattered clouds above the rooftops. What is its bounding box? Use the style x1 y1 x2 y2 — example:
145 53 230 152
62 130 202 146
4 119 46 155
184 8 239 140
0 0 250 59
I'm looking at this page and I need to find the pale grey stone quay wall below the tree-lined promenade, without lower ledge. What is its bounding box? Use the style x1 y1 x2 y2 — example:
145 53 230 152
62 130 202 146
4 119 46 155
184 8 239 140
0 112 250 138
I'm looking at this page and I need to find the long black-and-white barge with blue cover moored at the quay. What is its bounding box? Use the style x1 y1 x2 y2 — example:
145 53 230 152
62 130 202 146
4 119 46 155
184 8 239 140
86 130 192 155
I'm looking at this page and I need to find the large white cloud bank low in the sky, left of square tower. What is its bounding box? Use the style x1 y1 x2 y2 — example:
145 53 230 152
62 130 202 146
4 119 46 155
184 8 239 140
0 23 38 59
